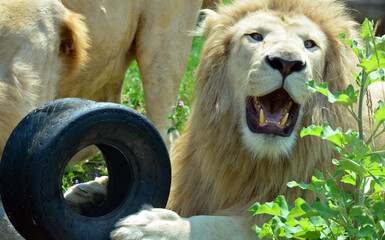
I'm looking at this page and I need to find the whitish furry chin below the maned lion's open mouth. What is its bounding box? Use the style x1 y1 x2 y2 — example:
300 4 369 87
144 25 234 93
242 125 300 162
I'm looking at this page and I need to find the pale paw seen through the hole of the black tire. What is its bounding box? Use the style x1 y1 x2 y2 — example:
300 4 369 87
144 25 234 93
64 176 108 213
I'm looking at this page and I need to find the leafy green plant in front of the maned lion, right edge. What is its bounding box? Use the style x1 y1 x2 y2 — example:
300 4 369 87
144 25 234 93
249 20 385 239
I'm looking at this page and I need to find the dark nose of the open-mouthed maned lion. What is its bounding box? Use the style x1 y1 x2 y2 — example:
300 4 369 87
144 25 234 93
266 56 306 79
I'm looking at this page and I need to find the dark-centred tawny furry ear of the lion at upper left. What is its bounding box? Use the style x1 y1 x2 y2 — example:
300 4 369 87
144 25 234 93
59 10 89 74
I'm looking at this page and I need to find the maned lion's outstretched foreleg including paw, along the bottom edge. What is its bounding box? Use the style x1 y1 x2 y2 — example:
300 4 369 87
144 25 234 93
111 206 257 240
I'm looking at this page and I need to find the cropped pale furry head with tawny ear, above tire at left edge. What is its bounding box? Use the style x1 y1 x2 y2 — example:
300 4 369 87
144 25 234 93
0 0 89 156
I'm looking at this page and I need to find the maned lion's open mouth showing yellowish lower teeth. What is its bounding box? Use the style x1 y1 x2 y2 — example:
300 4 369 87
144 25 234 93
246 88 299 137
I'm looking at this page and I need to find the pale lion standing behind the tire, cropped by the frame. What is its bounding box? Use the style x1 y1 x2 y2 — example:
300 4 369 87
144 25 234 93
0 0 210 239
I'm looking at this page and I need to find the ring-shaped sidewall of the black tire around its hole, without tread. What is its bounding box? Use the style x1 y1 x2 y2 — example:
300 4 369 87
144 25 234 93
0 99 171 239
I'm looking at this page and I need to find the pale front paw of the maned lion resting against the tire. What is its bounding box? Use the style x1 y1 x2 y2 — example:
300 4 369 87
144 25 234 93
111 205 190 240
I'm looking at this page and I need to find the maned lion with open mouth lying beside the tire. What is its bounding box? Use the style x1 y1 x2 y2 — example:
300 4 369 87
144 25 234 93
111 0 382 240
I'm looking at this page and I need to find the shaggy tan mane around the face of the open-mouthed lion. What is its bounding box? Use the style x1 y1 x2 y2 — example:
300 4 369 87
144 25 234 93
168 0 358 223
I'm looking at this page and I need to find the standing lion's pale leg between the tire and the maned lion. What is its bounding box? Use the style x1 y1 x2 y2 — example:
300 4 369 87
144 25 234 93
135 0 201 150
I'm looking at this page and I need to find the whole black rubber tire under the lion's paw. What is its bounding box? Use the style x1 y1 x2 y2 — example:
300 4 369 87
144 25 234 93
0 98 171 240
